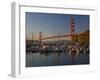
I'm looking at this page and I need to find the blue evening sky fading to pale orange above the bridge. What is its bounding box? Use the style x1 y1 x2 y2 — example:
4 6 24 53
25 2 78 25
25 12 89 38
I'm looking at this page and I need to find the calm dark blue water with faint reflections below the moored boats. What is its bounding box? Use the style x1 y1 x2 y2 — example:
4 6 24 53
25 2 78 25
26 52 89 67
